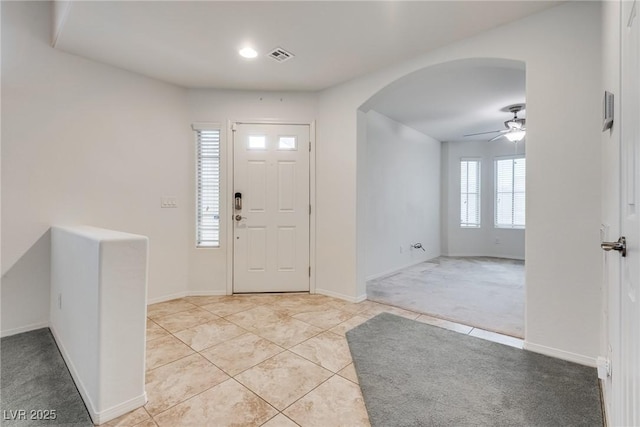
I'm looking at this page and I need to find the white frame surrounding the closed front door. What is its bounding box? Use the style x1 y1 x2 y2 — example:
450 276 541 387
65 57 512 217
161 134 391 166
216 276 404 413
224 119 316 295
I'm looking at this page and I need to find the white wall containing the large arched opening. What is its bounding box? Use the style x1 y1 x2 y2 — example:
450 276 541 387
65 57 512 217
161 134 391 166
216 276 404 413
318 2 602 363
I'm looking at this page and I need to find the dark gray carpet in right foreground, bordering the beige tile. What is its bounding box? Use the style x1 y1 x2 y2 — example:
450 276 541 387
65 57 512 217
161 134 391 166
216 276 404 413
347 313 603 427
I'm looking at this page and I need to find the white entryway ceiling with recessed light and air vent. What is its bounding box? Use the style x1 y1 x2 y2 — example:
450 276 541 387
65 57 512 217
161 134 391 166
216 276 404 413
55 0 561 91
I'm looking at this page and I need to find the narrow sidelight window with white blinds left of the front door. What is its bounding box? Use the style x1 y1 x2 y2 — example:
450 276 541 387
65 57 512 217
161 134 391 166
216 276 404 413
194 127 220 248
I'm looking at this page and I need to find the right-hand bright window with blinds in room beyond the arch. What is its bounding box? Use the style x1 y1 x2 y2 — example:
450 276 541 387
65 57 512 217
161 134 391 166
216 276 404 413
495 157 526 228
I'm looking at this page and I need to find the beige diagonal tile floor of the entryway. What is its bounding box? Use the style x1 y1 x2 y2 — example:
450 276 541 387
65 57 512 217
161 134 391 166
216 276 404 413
106 294 522 427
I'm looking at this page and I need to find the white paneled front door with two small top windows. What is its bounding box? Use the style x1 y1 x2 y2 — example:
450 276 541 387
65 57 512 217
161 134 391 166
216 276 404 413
232 123 310 293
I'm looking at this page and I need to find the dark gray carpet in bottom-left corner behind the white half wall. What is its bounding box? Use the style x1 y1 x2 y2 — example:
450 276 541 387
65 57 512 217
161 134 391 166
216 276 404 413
0 328 93 427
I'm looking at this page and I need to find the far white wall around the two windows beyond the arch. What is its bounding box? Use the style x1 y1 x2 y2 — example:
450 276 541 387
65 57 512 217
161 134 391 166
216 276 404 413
442 138 525 259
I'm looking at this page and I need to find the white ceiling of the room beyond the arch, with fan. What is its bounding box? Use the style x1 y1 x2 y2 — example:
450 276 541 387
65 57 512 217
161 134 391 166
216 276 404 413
365 59 526 141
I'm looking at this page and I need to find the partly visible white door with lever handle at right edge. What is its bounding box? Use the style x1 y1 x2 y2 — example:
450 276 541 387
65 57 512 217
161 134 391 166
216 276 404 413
612 1 640 426
